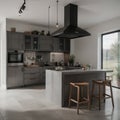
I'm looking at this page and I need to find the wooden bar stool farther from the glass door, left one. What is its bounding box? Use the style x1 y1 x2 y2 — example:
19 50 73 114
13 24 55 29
69 82 90 114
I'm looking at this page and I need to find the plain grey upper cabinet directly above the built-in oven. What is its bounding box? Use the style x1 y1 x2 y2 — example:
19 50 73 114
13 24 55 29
7 31 24 50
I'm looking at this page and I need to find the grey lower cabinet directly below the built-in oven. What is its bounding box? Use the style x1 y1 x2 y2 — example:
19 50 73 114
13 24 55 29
7 66 23 88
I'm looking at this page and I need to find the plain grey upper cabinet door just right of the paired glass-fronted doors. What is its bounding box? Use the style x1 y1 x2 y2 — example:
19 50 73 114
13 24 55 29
39 36 53 51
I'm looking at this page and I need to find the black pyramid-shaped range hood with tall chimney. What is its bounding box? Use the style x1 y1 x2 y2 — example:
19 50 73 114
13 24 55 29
52 4 90 39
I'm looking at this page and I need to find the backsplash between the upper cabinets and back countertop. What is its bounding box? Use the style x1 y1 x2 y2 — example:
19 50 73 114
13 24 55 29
24 51 66 65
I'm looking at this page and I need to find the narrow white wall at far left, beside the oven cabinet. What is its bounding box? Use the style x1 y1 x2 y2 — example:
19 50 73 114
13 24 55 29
0 18 7 89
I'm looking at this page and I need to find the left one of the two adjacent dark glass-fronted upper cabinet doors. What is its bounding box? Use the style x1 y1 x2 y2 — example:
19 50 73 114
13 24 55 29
25 35 32 50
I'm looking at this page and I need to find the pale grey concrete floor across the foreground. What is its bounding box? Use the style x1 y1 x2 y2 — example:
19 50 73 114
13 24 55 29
0 86 120 120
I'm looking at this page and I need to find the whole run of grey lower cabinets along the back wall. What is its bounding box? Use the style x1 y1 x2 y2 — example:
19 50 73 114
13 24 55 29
7 66 53 88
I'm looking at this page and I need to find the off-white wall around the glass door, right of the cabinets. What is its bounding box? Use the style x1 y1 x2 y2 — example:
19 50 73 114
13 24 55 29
71 17 120 68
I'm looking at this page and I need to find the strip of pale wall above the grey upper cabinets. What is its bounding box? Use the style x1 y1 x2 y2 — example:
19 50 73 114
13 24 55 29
6 19 54 33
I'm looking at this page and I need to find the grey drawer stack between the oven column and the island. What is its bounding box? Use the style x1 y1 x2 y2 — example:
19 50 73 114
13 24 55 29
24 67 42 85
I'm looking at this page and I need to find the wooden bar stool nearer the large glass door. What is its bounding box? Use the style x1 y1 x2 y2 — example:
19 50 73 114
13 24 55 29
91 80 114 110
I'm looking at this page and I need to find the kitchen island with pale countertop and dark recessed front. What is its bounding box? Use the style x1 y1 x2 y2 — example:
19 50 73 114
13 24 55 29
45 69 112 107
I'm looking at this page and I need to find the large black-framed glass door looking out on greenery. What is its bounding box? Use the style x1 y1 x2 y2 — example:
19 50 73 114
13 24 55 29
101 30 120 80
